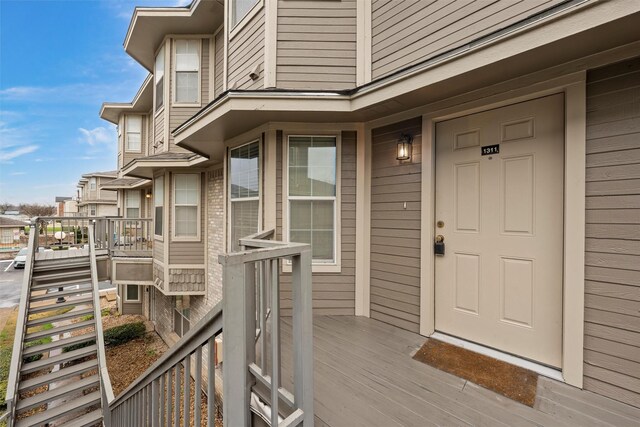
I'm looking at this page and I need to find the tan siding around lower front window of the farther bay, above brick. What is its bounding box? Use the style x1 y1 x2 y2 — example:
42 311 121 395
165 170 206 265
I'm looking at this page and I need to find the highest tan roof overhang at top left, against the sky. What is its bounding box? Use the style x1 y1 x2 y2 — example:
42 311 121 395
124 0 224 72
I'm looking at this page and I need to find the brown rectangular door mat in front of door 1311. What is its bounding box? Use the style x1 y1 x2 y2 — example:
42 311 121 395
413 338 538 407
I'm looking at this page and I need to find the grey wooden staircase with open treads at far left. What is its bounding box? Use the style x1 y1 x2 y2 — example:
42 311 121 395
14 256 102 427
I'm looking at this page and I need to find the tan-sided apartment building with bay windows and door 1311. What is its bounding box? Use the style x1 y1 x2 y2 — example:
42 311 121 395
95 0 640 418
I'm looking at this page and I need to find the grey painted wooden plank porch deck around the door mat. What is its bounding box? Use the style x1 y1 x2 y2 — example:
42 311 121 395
282 316 640 427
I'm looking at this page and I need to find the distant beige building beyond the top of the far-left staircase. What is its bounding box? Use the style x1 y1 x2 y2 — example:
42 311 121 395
77 171 118 216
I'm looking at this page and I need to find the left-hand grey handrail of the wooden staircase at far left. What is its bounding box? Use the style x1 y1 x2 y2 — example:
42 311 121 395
5 217 39 426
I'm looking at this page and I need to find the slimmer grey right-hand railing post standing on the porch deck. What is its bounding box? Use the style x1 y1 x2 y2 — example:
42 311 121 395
292 247 314 427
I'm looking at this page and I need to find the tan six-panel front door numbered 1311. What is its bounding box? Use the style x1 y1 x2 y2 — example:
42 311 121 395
435 95 564 367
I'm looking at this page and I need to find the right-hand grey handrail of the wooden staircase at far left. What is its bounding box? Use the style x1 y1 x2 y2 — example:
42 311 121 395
89 220 115 427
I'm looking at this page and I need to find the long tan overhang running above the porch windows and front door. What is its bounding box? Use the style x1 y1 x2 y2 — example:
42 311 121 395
172 0 640 160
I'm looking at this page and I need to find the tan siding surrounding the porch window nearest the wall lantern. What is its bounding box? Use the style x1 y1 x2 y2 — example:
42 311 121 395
276 132 356 315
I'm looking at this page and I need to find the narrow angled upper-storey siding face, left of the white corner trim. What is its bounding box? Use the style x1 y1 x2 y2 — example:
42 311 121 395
227 8 264 89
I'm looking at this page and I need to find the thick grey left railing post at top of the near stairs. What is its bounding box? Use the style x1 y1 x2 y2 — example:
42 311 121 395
222 263 256 426
